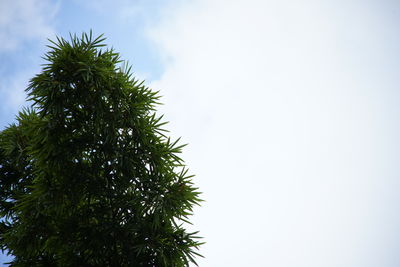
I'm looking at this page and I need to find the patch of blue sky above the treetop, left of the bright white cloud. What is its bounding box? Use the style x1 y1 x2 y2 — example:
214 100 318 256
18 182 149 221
0 0 165 129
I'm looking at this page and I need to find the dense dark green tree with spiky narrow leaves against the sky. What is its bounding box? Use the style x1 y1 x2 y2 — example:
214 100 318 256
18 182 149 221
0 33 201 266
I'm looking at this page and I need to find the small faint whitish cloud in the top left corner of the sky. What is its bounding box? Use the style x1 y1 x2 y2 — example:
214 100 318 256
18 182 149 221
0 0 58 52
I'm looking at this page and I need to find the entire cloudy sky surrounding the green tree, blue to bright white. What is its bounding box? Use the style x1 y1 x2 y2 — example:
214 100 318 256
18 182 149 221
0 0 400 267
